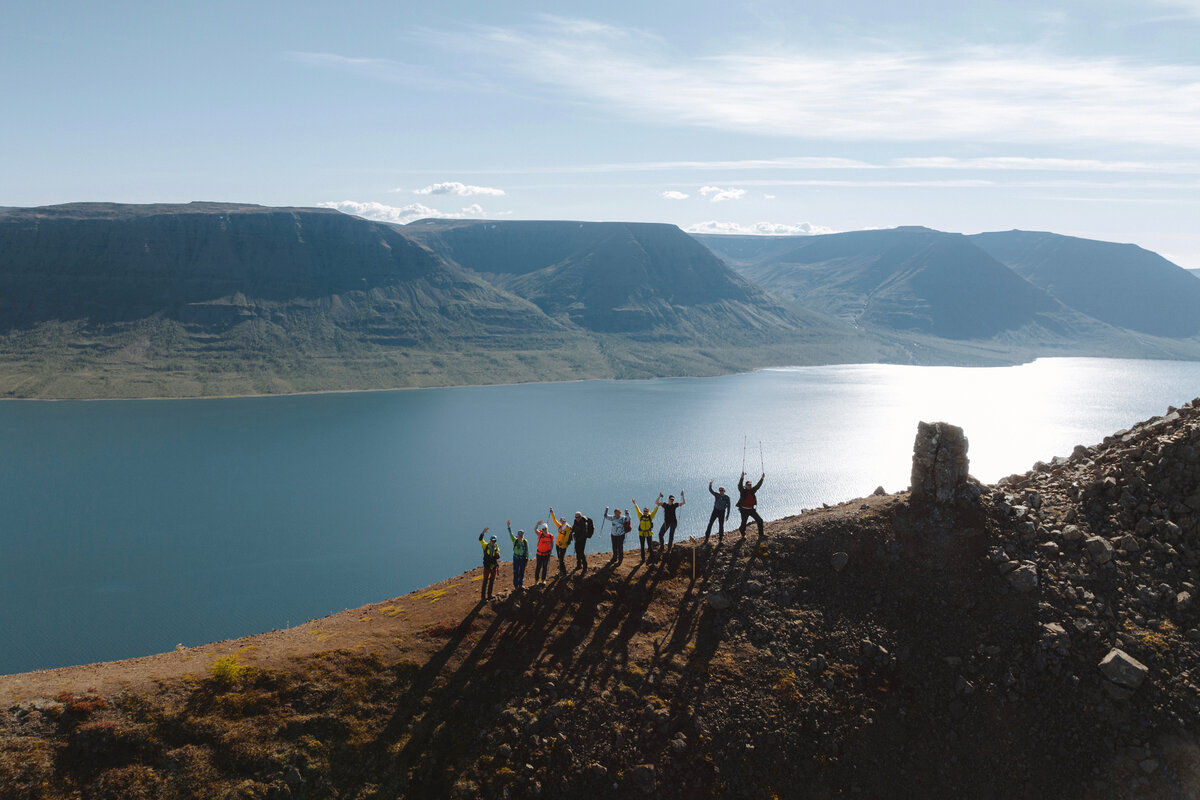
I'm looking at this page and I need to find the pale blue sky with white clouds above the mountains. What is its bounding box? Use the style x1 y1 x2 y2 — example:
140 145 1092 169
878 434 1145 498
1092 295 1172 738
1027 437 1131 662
0 0 1200 269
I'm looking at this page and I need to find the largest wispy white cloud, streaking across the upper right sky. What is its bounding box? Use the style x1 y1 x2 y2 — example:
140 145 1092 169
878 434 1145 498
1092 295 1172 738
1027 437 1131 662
456 16 1200 149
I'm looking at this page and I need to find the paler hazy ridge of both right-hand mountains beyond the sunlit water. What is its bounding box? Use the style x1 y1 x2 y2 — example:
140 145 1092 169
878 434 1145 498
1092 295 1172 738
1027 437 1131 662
696 227 1200 347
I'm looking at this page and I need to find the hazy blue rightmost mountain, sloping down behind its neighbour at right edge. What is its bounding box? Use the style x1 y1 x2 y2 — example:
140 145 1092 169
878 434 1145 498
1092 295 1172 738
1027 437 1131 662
970 230 1200 337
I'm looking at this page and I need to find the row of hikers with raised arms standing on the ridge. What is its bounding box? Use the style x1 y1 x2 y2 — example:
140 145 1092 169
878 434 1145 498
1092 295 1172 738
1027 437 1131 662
479 473 767 600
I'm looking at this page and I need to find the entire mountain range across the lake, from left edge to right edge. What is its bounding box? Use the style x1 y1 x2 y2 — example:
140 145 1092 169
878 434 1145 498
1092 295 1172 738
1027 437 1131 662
0 203 1200 397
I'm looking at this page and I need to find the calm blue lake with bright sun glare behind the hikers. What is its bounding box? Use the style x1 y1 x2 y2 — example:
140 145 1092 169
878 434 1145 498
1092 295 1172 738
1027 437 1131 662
0 359 1200 674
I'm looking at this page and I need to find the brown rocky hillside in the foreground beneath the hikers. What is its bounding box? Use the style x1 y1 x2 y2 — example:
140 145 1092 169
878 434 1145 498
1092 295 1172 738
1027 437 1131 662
0 401 1200 800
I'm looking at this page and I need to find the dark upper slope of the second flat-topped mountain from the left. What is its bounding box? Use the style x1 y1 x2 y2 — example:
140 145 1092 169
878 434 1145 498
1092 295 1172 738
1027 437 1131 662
404 219 816 339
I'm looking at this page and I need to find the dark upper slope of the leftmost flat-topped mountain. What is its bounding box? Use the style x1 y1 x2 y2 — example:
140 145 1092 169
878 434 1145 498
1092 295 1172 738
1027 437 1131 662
0 203 559 343
